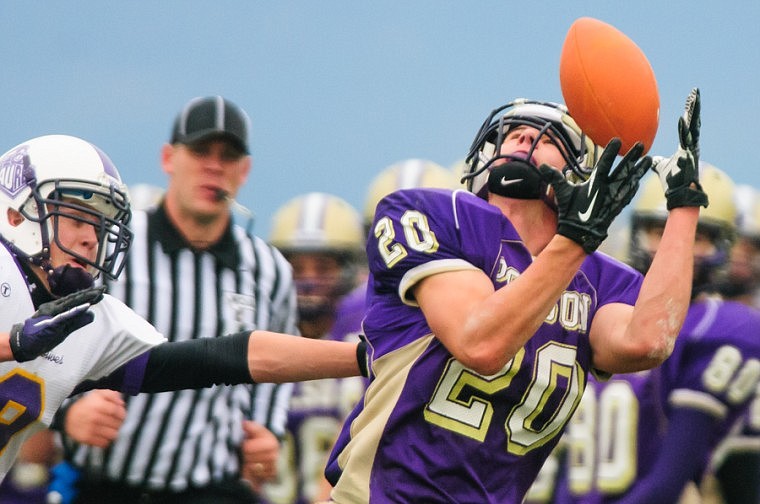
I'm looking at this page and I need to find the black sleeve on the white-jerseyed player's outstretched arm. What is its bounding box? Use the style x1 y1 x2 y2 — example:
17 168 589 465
140 331 253 392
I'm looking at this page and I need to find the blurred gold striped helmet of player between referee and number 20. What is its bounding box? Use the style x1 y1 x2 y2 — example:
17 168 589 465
269 192 365 321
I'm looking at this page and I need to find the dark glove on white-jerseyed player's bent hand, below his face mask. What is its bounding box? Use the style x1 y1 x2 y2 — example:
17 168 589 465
10 287 105 362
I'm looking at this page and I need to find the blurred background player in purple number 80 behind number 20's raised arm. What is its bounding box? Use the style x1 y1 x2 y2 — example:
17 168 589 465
532 163 760 503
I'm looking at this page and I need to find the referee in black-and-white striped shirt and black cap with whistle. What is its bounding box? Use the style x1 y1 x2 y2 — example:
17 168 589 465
53 96 298 504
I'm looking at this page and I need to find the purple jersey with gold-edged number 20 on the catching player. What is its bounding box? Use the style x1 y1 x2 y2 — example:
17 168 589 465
326 189 641 504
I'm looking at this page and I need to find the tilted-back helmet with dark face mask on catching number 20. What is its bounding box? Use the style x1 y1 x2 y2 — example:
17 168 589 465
462 98 599 199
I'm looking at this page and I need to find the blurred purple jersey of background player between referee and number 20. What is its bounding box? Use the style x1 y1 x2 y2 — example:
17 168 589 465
264 284 366 504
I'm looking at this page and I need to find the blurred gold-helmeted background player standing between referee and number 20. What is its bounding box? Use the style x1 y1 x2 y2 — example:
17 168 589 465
264 192 365 504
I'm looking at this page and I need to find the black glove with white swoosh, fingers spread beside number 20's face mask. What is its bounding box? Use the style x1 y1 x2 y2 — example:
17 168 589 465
539 138 652 254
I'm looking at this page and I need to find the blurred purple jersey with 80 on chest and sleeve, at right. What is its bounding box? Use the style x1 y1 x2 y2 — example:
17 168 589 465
544 299 760 503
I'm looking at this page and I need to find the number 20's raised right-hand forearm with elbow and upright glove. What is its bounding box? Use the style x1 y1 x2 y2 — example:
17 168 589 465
590 89 707 373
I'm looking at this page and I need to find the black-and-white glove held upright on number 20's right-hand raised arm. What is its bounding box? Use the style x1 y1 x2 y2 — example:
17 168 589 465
652 88 708 210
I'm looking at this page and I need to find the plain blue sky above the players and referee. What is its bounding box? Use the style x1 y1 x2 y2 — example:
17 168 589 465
0 0 760 237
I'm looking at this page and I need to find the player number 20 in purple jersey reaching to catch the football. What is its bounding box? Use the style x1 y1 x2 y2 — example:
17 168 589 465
327 90 707 504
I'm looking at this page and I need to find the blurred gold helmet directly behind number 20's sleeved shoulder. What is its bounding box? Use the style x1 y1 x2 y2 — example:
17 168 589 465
364 159 459 228
